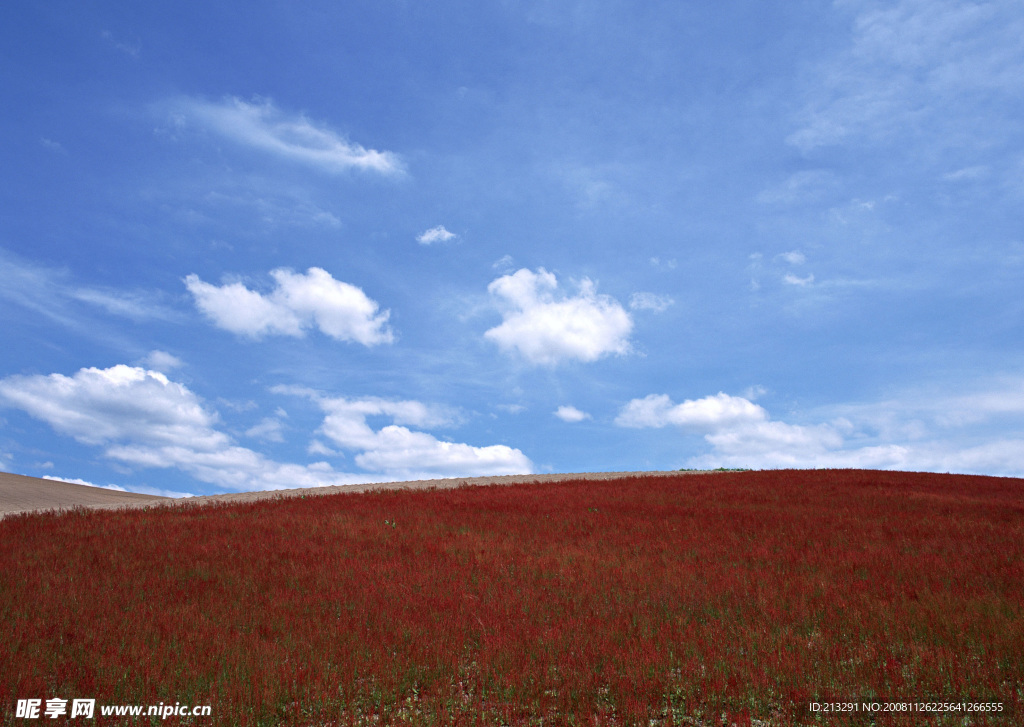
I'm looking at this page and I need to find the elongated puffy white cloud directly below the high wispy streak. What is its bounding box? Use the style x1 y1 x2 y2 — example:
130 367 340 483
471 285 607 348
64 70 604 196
185 267 394 346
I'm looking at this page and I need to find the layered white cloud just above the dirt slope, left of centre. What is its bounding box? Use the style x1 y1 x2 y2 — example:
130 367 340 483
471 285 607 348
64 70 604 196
275 387 534 479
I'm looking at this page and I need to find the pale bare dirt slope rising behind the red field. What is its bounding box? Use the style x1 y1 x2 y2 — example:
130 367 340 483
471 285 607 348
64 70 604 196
0 471 695 518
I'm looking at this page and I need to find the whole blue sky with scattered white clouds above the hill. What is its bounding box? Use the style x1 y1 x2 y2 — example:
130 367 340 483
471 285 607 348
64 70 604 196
0 0 1024 495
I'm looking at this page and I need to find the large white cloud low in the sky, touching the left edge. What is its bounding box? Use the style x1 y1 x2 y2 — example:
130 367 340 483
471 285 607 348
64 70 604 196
0 365 381 490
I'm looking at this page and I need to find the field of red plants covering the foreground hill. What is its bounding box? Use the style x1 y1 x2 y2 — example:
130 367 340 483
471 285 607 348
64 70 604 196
0 470 1024 726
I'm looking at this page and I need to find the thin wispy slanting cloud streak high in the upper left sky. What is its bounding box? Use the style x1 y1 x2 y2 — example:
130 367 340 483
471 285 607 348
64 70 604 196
171 97 403 175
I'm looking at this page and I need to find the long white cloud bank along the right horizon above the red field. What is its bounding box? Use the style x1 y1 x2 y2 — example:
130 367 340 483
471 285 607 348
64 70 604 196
615 382 1024 476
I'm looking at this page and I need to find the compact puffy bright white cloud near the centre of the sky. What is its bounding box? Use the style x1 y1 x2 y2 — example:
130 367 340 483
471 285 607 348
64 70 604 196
484 267 633 366
